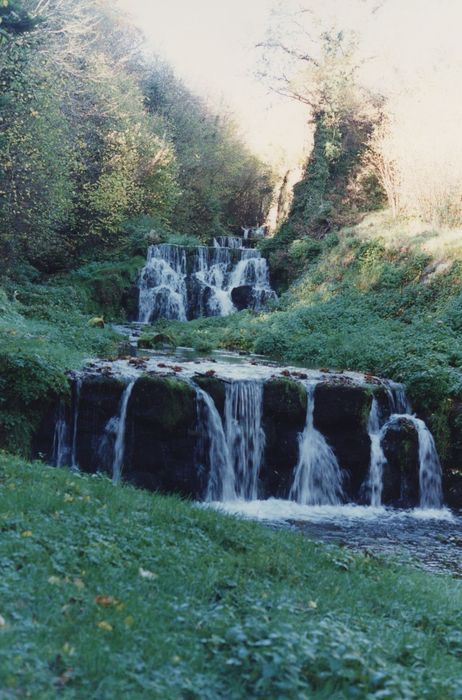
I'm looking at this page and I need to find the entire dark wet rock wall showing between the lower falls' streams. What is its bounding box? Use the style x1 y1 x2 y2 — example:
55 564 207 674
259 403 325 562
35 370 448 507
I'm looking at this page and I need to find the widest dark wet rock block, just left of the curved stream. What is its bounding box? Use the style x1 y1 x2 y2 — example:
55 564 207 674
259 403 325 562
124 377 200 498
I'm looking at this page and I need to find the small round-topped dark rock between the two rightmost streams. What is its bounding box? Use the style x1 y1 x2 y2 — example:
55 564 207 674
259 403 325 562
382 418 419 508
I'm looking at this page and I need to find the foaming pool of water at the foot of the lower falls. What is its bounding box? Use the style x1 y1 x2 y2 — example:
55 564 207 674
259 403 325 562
210 499 462 578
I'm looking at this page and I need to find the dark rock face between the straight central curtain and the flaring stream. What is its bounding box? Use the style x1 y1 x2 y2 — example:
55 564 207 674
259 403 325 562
260 378 307 498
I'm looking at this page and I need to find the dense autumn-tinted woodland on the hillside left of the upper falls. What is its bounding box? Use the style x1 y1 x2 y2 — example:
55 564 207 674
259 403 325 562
0 0 272 272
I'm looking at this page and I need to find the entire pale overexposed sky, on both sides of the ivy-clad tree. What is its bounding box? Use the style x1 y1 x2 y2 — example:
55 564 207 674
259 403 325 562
114 0 462 168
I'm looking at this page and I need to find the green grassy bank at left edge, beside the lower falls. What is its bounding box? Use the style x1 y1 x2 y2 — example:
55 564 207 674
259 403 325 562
0 283 120 455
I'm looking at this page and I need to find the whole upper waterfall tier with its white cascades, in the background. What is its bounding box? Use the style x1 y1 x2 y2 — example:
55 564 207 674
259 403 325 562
138 236 276 323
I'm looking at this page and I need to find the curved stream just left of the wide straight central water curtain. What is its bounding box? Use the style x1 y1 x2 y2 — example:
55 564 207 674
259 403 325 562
195 386 236 501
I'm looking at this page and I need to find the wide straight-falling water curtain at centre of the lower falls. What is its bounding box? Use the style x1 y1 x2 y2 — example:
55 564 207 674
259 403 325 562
225 380 265 500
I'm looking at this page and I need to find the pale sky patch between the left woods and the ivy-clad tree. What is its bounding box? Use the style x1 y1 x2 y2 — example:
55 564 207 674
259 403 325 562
115 0 307 165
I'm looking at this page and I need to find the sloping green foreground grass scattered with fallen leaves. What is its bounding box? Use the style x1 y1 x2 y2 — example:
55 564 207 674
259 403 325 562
0 453 462 700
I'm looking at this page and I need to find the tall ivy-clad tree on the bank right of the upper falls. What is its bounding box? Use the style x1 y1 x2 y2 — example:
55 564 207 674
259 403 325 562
260 30 382 239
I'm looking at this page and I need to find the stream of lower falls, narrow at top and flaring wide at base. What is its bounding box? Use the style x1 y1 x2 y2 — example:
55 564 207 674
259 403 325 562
289 382 343 506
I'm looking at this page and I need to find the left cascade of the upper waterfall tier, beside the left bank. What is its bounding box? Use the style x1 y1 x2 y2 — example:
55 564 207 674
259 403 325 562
138 243 187 323
